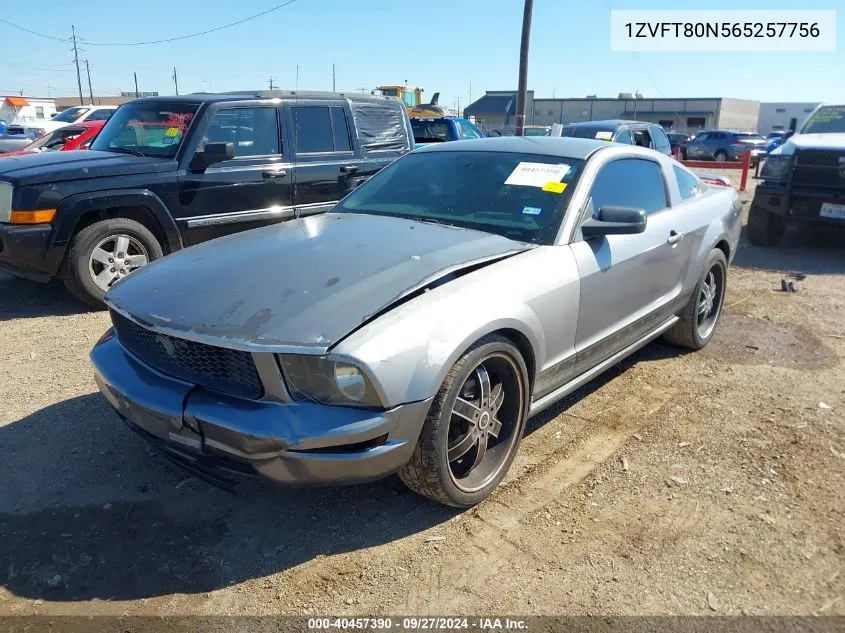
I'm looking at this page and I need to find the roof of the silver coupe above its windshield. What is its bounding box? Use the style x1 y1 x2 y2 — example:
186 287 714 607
415 136 610 160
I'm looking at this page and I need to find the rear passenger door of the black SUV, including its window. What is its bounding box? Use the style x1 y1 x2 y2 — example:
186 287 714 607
288 101 361 216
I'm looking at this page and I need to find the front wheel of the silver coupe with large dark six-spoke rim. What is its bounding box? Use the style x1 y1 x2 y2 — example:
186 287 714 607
399 335 529 508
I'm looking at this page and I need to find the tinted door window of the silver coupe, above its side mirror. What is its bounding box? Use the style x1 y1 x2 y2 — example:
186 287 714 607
590 158 666 214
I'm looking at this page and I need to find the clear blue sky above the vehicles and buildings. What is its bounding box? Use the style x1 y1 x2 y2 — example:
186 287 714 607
0 0 845 107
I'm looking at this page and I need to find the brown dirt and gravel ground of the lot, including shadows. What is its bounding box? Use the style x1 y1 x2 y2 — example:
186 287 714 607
0 172 845 615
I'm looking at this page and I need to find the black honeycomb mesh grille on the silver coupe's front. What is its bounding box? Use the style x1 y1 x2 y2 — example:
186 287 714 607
111 311 263 398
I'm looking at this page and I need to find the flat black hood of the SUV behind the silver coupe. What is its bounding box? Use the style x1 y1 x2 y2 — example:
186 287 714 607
0 150 176 186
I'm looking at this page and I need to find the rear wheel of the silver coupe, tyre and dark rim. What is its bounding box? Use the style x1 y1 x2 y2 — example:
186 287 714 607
663 248 728 350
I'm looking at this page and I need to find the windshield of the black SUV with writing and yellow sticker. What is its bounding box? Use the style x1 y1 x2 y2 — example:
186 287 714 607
91 101 198 158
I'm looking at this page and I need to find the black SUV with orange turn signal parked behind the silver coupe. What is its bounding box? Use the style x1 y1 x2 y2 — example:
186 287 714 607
0 91 414 306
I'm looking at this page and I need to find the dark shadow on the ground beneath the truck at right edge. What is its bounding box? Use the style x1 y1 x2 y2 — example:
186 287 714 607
733 227 845 275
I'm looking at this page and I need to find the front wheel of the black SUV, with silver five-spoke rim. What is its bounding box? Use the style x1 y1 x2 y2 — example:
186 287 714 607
62 218 163 308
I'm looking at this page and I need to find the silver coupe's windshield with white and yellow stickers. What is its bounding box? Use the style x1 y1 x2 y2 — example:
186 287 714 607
335 151 584 244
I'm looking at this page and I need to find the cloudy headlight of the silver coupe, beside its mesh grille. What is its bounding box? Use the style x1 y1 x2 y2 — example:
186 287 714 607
279 354 382 408
